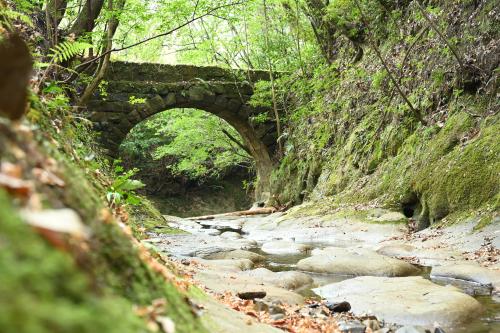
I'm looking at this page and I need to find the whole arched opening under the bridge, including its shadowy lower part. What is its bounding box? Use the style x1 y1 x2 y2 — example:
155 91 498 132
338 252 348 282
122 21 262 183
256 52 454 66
118 109 256 216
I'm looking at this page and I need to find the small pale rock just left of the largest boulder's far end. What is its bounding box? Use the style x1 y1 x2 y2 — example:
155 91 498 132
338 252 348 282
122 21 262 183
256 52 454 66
243 267 313 290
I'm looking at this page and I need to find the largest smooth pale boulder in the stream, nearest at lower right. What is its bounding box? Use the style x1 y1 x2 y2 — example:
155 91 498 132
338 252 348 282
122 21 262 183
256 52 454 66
313 276 482 326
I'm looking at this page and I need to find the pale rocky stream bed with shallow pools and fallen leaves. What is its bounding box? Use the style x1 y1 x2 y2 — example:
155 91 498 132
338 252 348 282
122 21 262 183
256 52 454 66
149 206 500 333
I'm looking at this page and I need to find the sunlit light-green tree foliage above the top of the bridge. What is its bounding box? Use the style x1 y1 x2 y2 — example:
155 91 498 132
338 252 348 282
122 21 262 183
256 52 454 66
111 0 317 70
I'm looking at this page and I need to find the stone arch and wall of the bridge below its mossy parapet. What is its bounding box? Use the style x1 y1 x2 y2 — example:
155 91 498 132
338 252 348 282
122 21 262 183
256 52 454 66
88 71 276 201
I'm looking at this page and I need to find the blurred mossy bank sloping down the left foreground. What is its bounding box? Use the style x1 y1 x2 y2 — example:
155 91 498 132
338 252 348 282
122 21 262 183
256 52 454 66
0 113 205 333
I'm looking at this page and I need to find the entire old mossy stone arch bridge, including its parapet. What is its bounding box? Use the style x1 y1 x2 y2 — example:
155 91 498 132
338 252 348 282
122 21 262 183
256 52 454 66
87 62 277 200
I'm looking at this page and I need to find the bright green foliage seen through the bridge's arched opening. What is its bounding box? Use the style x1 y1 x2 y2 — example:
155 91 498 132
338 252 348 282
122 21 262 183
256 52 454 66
121 109 251 182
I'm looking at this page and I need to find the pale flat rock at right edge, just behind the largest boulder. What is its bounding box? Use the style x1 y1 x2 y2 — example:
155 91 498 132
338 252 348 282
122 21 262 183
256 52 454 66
431 264 500 294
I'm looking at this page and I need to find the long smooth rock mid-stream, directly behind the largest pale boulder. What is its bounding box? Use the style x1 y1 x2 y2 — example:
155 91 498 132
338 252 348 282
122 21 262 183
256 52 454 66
297 247 419 276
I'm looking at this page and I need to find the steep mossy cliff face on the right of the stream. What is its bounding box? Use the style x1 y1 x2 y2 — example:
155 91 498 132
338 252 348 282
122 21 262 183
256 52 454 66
272 1 500 228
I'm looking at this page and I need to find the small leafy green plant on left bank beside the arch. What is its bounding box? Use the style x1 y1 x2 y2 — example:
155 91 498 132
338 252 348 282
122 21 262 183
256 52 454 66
106 160 145 206
